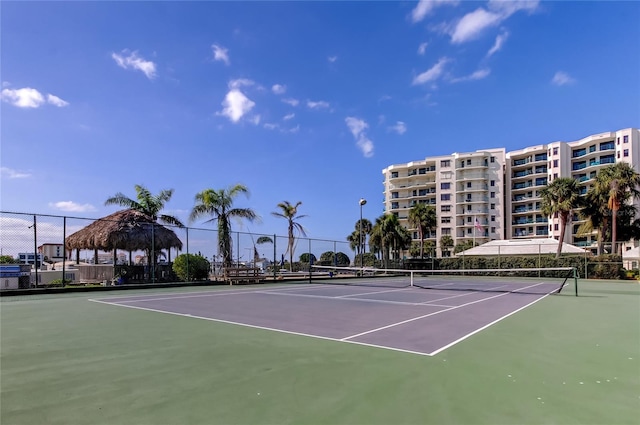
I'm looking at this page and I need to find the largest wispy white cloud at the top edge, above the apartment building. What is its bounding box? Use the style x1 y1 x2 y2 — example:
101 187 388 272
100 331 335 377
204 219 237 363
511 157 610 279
450 0 539 44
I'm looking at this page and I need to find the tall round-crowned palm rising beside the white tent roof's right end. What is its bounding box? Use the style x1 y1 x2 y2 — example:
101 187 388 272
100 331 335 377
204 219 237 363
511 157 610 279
540 177 582 258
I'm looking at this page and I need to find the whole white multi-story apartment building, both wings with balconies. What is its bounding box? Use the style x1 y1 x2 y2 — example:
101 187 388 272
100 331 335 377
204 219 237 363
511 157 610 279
382 128 640 255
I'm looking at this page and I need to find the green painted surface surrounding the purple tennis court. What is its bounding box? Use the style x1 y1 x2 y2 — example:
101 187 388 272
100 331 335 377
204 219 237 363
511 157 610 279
0 281 640 424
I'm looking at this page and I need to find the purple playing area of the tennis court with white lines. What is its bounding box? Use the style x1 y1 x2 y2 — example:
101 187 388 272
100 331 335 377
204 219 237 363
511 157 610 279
92 270 559 355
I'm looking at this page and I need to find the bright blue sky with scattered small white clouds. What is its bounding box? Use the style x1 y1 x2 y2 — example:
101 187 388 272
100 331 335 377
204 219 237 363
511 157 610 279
0 0 640 240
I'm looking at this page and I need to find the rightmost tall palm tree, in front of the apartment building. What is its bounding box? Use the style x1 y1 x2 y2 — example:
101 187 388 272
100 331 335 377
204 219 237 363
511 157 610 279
596 162 640 253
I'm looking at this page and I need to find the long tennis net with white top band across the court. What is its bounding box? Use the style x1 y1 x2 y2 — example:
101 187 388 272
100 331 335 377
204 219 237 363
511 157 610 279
309 266 578 295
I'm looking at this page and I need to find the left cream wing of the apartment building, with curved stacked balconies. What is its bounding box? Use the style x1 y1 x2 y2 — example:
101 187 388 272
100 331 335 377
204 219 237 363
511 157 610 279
382 148 505 255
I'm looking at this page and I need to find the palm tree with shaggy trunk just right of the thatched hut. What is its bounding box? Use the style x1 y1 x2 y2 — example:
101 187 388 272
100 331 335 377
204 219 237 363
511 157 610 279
189 184 258 267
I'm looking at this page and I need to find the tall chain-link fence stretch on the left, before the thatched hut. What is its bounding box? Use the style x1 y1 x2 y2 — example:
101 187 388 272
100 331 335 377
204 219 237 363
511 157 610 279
0 211 354 289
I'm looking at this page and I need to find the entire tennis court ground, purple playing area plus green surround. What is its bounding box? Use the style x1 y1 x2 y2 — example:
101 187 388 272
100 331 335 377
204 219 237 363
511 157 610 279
0 277 640 425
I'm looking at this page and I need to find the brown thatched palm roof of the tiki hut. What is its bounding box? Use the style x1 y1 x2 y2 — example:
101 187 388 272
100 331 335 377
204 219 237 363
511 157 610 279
66 210 182 251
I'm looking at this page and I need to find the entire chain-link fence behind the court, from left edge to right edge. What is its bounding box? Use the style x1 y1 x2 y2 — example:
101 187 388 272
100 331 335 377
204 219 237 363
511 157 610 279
0 212 640 289
